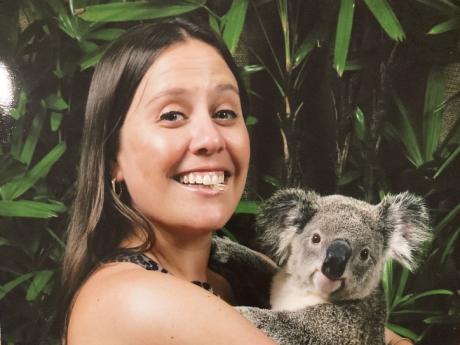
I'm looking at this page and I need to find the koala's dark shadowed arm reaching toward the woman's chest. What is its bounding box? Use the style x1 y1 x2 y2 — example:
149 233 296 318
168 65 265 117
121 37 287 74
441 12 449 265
209 237 279 308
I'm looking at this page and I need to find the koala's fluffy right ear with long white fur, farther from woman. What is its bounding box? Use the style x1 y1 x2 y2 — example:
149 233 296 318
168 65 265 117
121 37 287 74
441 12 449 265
377 192 431 270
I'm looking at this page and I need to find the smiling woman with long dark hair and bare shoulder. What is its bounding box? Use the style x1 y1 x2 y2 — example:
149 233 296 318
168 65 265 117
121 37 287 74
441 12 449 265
63 19 410 345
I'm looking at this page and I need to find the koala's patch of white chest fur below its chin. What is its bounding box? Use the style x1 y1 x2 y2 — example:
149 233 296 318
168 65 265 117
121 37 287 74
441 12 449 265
270 269 328 311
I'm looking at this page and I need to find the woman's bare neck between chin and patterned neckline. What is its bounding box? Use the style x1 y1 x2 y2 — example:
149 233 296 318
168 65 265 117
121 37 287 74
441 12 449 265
124 226 212 281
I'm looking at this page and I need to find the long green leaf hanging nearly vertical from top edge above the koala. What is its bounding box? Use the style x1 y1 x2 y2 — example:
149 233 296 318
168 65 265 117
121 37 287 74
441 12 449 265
334 0 355 76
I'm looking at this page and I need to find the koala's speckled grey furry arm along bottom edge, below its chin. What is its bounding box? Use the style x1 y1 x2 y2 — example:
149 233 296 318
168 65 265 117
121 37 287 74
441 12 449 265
238 289 386 345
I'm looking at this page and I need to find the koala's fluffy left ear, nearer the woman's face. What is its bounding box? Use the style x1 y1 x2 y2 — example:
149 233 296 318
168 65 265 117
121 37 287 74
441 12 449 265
257 188 319 266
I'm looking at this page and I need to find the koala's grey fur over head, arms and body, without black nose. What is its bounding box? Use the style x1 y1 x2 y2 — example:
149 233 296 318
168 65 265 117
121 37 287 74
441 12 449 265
210 189 430 345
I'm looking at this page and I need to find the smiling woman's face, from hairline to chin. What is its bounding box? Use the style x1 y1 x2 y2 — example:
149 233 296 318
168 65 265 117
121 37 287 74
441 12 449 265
113 39 250 234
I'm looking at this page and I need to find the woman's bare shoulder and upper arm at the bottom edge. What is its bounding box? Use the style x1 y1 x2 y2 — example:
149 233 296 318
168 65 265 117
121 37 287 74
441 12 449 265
68 263 274 345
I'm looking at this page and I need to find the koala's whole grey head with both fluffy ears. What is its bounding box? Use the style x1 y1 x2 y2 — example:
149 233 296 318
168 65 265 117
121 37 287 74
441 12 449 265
257 189 430 301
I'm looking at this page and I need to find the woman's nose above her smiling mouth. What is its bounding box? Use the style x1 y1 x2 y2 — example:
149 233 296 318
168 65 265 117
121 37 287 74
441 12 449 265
190 115 225 155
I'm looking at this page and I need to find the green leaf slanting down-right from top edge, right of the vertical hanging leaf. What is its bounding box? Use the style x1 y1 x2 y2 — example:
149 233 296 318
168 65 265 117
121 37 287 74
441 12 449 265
364 0 406 41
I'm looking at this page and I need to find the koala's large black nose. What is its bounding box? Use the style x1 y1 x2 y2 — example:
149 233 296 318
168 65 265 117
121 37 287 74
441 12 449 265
321 240 351 280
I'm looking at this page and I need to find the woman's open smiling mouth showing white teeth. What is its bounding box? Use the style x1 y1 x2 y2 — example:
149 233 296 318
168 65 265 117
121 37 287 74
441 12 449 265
173 170 231 190
